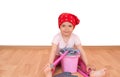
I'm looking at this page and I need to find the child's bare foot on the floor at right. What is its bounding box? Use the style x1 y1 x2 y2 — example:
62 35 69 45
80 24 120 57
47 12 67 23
90 68 107 77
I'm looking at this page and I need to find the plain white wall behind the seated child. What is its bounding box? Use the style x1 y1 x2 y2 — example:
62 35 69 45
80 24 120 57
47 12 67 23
0 0 120 45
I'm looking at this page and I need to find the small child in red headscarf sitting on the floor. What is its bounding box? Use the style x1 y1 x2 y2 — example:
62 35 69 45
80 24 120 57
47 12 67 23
44 13 105 77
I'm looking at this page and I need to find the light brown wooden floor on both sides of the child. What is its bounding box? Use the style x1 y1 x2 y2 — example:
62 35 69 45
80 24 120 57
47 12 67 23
0 46 120 77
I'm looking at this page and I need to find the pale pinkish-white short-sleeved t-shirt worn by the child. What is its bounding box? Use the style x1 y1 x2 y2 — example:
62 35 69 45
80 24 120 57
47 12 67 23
52 33 81 54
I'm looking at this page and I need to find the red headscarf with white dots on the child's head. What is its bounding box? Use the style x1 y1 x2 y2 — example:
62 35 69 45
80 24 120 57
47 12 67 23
58 13 80 28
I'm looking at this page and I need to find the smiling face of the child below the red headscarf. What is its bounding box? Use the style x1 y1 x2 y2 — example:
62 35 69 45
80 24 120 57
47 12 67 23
60 22 74 36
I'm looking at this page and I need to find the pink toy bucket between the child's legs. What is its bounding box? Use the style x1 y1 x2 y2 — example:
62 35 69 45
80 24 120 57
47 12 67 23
61 55 79 73
